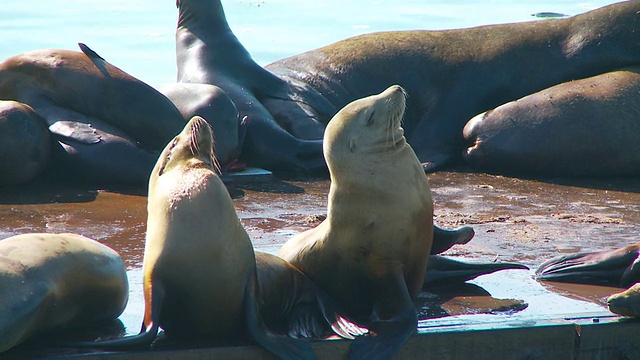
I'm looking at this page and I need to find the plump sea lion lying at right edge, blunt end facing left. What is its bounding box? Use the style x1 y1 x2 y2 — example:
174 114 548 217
463 66 640 176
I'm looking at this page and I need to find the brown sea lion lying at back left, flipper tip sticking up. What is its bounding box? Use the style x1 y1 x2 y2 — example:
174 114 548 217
0 44 185 185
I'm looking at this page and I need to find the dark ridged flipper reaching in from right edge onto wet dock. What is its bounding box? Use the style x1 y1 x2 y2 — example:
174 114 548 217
536 243 640 288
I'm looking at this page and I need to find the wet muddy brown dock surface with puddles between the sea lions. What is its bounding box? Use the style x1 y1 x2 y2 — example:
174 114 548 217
0 172 640 356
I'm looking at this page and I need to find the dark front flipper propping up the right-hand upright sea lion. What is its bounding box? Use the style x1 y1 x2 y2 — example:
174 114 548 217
349 271 418 359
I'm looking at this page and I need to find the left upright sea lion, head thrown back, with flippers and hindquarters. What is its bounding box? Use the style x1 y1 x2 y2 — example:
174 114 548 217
76 116 362 359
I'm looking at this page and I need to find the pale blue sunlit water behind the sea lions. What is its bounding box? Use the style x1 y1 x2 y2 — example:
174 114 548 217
0 0 615 85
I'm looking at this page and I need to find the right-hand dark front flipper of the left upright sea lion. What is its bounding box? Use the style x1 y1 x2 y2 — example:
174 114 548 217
244 275 316 359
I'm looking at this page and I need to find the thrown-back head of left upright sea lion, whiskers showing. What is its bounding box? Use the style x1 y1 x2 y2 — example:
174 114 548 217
153 116 220 176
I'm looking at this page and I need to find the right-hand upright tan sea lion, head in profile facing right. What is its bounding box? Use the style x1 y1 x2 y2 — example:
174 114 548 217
279 85 434 358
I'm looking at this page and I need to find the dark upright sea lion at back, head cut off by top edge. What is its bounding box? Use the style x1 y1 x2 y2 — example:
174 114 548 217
176 0 335 174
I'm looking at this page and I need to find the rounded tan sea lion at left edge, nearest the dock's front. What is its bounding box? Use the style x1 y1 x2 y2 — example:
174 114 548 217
0 234 129 352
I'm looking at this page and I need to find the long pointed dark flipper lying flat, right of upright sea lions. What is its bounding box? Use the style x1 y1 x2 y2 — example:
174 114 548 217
422 255 529 288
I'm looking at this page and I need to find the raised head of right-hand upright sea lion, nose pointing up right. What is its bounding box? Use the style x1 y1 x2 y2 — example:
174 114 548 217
323 85 407 167
